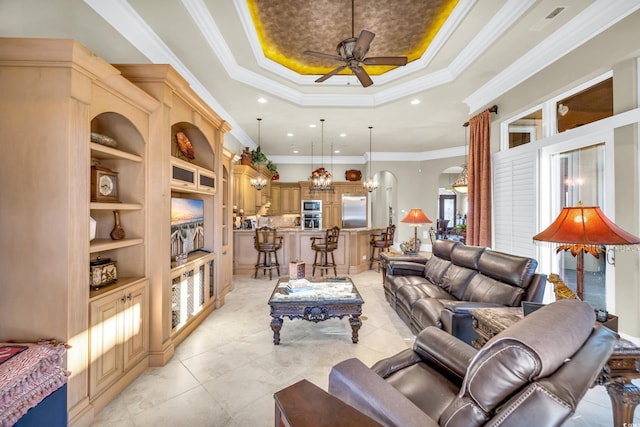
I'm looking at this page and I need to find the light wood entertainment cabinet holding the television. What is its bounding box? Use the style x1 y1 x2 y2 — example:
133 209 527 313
116 64 233 366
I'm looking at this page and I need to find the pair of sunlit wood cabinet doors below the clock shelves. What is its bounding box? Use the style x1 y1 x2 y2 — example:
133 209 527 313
89 280 149 399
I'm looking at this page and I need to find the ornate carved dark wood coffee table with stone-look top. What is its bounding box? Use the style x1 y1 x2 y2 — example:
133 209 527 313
269 277 364 345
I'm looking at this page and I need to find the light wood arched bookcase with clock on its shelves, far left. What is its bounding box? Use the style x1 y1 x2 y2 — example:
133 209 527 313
0 38 160 425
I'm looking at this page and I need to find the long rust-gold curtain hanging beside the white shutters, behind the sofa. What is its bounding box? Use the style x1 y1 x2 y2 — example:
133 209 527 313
467 109 491 246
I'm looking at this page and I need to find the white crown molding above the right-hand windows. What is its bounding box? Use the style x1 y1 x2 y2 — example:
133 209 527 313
464 0 640 114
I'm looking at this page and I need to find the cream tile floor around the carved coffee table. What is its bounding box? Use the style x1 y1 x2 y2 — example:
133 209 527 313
93 271 640 427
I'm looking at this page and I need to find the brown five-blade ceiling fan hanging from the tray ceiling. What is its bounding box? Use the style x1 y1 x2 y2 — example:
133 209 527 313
304 0 407 87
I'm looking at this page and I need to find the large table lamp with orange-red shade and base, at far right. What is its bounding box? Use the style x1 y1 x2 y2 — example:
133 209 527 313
533 202 640 300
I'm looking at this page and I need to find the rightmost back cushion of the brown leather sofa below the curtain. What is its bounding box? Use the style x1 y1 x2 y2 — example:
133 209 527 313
478 249 538 288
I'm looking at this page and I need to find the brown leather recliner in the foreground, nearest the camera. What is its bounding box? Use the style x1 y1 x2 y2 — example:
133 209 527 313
329 300 618 427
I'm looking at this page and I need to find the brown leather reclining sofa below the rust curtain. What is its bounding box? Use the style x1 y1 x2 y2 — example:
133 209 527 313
384 240 547 344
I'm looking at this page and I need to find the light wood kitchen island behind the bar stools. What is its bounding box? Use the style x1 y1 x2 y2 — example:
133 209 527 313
233 227 384 277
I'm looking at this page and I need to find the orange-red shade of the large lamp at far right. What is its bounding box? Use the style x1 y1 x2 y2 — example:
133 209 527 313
533 206 640 246
